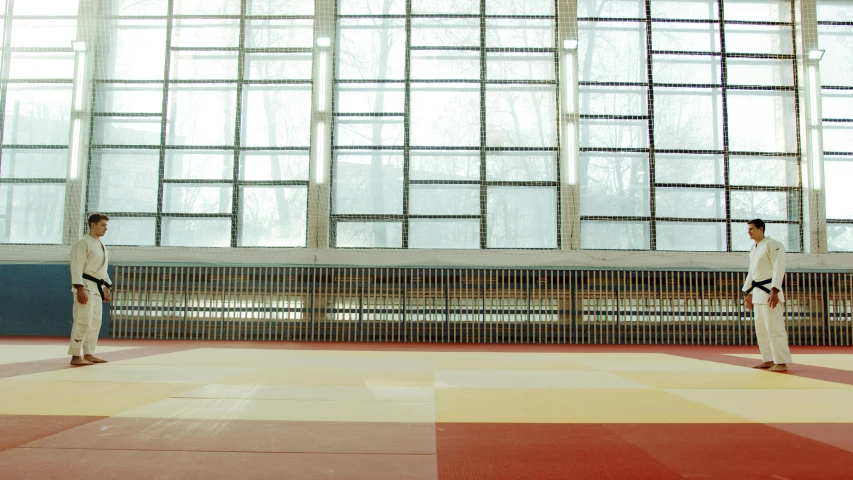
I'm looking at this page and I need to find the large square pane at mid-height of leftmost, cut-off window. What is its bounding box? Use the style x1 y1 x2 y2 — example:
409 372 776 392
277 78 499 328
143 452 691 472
3 84 71 145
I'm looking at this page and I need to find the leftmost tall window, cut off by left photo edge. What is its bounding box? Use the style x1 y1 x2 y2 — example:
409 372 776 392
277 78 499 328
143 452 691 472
0 0 78 244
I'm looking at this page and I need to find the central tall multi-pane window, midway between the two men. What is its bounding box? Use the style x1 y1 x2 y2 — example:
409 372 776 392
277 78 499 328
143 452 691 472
332 0 559 248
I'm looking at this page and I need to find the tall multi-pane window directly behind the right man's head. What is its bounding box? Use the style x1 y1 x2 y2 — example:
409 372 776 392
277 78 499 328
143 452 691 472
578 0 802 251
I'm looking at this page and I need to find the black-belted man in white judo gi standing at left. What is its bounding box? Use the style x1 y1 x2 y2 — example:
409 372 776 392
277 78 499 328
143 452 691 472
68 213 112 365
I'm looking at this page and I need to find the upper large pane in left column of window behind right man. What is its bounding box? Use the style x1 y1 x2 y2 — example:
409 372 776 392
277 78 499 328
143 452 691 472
578 22 648 83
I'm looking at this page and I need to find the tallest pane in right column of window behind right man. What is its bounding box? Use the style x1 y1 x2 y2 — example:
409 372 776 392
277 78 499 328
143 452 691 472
728 90 797 152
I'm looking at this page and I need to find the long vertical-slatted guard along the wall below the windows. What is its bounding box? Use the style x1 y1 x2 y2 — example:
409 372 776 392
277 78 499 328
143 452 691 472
111 266 853 346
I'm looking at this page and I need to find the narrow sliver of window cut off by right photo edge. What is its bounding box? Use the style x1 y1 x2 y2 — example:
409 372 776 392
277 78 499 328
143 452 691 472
817 0 853 252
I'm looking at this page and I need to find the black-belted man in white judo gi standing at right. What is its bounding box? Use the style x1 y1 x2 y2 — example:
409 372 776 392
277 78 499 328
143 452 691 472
743 219 791 372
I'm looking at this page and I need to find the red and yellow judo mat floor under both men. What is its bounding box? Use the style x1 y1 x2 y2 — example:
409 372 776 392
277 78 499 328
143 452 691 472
0 337 853 480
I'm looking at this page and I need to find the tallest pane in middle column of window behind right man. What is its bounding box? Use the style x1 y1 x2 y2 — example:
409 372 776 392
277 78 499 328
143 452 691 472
654 88 720 150
